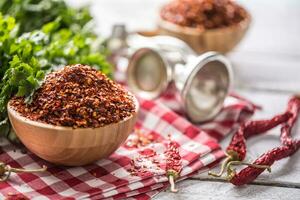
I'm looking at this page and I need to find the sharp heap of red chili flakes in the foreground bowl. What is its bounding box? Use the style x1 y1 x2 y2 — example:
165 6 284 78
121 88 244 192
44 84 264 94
10 64 136 128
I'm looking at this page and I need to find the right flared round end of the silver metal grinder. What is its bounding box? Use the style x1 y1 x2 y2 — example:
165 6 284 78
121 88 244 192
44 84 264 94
175 52 233 122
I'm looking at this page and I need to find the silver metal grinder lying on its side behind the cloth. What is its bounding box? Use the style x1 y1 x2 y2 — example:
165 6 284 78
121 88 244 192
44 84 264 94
109 24 233 123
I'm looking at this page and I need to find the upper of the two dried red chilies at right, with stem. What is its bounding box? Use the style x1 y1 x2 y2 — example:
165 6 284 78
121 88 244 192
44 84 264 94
209 112 291 177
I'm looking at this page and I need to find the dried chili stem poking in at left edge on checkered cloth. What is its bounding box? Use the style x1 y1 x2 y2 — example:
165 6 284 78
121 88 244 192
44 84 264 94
0 162 47 182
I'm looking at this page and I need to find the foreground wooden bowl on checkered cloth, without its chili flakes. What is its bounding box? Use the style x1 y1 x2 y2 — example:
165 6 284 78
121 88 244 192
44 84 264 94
7 96 139 166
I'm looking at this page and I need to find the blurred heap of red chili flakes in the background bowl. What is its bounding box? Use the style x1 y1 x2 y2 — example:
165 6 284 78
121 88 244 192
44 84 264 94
160 0 247 30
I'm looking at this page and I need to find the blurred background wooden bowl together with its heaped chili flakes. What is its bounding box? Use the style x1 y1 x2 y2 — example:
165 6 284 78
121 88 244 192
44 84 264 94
158 0 251 53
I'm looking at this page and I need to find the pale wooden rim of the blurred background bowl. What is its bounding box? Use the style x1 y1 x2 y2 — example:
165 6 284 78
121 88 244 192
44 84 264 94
158 8 252 36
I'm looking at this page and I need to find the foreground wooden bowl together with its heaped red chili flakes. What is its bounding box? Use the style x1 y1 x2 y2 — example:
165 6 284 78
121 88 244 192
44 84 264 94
8 65 139 166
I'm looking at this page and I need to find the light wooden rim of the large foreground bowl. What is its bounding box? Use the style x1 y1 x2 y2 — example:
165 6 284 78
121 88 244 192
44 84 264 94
7 91 140 131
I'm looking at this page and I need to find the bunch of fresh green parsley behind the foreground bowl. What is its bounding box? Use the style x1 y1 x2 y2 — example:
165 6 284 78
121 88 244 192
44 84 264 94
0 0 112 140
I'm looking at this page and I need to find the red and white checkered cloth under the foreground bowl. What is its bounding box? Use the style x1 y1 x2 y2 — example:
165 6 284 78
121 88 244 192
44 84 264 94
0 90 255 200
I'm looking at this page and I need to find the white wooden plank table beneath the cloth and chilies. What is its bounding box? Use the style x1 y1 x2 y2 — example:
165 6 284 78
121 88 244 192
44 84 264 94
65 0 300 200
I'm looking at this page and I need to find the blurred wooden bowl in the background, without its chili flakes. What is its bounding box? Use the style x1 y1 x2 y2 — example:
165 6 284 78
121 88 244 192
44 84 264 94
158 14 251 54
